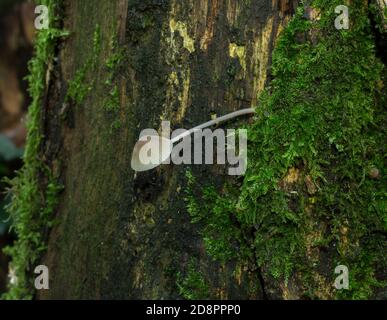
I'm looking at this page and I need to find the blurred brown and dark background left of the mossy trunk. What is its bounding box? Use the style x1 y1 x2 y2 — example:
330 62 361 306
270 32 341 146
0 0 35 296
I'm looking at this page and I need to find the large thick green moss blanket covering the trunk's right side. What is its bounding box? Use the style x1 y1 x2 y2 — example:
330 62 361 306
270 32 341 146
189 0 387 299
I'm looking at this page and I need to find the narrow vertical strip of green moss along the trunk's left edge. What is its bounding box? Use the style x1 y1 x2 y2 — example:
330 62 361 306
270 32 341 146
4 0 68 299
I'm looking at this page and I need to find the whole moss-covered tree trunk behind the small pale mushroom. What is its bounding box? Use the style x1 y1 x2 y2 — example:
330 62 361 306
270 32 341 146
15 0 387 299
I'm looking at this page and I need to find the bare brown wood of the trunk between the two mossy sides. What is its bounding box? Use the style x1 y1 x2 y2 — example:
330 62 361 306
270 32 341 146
38 0 296 299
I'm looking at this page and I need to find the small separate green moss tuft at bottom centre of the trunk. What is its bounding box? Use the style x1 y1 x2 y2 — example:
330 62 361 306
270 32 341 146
176 259 210 300
